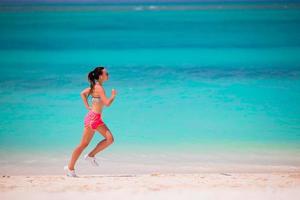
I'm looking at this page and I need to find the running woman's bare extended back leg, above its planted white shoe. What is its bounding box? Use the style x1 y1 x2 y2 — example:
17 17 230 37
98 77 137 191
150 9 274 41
69 127 95 170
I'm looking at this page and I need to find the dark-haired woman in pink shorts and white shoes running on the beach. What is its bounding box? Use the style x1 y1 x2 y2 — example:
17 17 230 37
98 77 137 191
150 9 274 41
64 67 116 177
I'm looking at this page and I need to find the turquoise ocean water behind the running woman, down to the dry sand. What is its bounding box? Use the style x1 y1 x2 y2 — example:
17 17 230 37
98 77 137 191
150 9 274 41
0 1 300 173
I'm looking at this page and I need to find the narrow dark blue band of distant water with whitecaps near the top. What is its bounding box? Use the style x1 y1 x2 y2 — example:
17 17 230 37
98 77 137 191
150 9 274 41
0 2 300 12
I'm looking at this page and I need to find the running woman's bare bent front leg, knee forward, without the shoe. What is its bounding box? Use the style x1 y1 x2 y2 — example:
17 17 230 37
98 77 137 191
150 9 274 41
88 124 114 157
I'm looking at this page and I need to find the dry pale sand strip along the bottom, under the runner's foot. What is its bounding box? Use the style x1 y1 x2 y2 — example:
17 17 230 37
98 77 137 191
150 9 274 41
0 171 300 200
